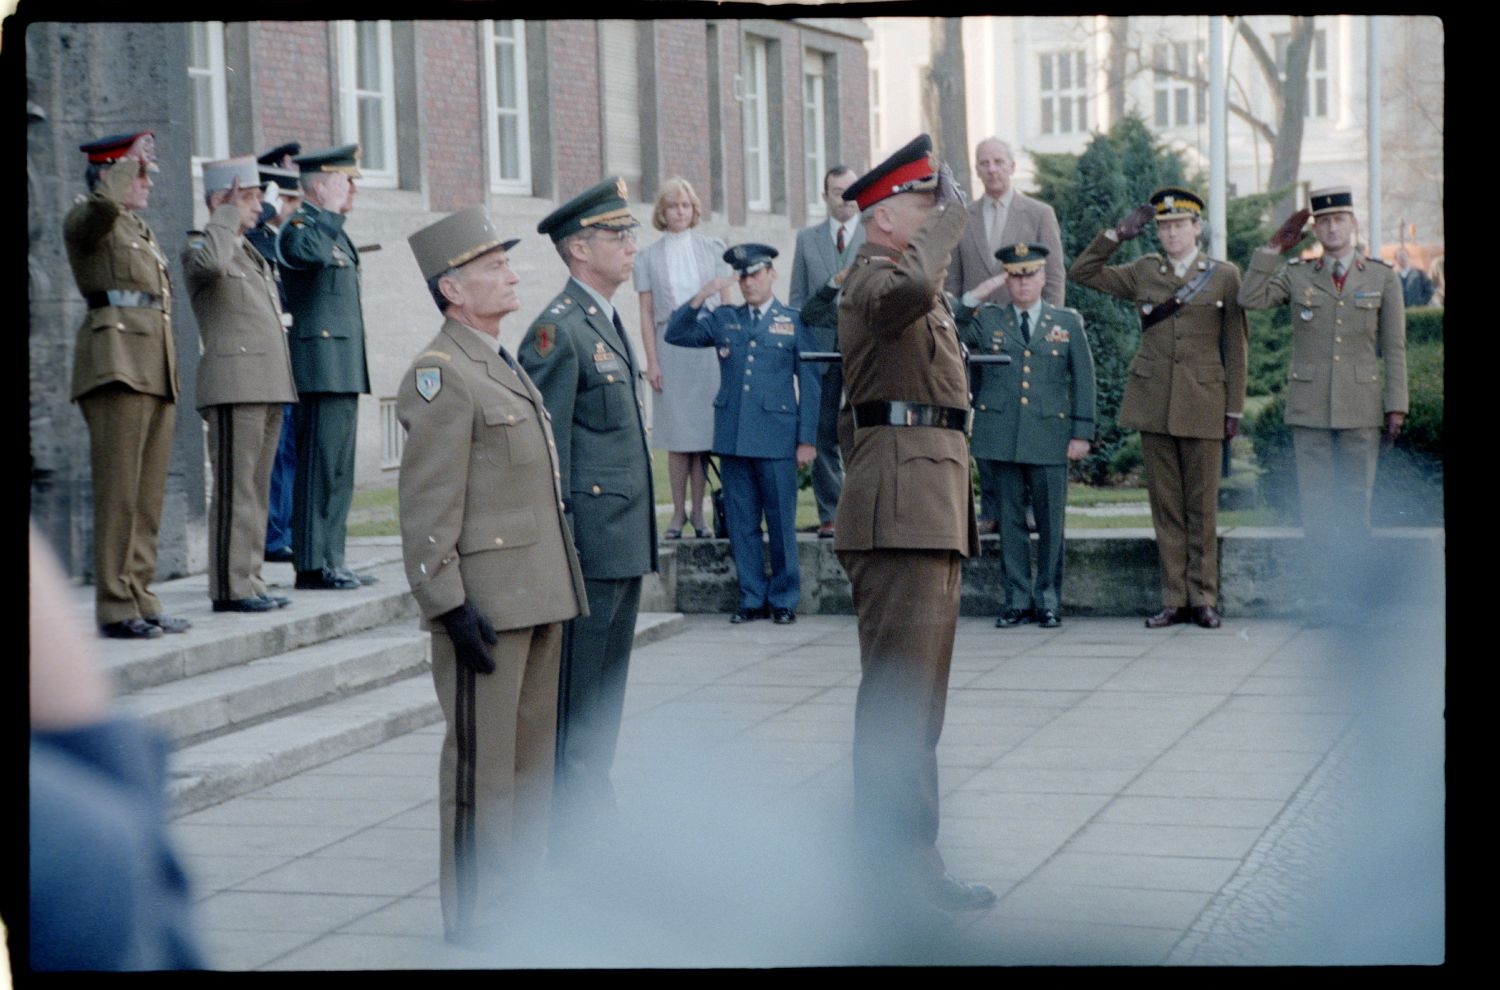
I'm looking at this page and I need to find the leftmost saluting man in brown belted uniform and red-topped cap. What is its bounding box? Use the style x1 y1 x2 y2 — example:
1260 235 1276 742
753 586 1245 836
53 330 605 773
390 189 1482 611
63 131 191 639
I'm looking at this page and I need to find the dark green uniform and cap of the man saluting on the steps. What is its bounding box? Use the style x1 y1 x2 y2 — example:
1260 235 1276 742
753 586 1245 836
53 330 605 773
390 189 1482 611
276 146 371 587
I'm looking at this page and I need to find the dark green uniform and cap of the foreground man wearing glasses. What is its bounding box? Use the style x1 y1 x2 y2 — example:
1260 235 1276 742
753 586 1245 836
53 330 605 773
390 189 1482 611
518 179 657 842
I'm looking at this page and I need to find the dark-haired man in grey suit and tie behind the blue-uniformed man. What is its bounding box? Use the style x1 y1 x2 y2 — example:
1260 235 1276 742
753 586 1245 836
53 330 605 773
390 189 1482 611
788 165 864 540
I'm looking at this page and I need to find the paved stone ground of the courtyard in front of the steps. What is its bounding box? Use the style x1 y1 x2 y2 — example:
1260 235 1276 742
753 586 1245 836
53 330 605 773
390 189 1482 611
171 591 1445 971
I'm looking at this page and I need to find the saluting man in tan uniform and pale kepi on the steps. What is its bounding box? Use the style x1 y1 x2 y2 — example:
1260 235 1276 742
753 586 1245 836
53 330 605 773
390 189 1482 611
183 155 297 612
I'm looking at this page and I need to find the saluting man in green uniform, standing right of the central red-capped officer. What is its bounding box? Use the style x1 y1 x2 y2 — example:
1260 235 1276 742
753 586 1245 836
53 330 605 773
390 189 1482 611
954 243 1094 629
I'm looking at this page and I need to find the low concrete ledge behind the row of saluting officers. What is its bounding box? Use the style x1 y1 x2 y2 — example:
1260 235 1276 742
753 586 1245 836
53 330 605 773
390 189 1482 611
656 527 1446 617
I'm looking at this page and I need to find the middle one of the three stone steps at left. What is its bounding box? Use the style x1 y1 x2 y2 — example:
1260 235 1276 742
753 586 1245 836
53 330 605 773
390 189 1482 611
119 620 431 746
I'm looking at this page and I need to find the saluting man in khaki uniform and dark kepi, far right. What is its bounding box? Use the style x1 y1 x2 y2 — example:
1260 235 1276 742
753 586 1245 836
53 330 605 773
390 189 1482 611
1239 186 1407 612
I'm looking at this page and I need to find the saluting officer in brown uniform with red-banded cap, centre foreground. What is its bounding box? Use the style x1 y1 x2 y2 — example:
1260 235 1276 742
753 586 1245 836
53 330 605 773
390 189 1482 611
834 134 995 909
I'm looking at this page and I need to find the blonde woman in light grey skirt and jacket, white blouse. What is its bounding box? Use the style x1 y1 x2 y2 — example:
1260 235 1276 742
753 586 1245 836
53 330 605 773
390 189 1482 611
635 177 729 540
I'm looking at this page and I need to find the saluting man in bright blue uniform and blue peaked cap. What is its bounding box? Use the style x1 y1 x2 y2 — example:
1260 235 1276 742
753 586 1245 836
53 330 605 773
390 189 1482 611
666 245 821 626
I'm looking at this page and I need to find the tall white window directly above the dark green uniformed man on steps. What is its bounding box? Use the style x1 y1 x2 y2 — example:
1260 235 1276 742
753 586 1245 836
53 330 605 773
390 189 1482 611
338 21 396 186
